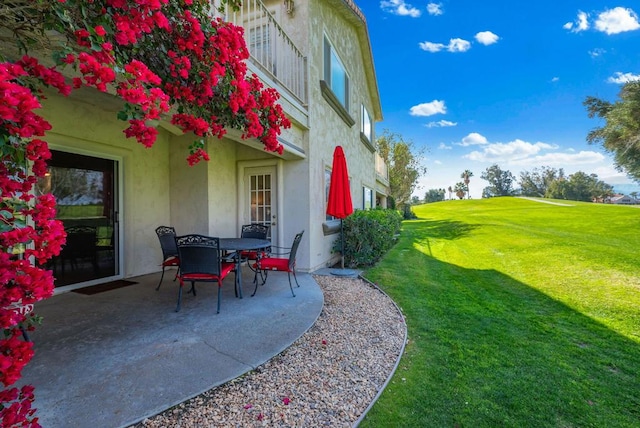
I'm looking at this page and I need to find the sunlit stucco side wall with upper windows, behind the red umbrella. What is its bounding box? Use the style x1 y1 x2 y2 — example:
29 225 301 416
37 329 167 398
309 1 376 269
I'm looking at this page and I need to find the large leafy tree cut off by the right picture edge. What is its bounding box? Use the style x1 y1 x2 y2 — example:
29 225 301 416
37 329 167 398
583 81 640 182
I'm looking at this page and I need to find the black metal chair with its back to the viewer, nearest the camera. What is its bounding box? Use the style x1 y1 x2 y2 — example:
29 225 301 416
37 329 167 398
176 234 235 313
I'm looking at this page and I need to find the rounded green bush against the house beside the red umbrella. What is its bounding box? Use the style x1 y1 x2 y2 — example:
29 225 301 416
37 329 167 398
334 209 402 267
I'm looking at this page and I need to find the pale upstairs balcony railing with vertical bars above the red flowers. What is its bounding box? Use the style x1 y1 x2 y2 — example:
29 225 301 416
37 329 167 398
226 0 308 106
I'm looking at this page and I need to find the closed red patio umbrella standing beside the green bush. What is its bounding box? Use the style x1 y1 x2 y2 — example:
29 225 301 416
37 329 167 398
327 146 353 269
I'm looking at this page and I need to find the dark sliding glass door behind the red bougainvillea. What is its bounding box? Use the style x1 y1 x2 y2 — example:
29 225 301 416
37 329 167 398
38 150 120 287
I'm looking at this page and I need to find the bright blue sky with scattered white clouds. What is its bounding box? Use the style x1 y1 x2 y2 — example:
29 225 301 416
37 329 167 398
357 0 640 198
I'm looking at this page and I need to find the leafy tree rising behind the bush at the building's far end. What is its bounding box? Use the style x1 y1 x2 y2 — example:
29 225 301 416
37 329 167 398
376 130 427 208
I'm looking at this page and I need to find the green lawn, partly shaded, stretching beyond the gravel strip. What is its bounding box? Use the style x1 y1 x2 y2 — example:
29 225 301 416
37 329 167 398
361 198 640 427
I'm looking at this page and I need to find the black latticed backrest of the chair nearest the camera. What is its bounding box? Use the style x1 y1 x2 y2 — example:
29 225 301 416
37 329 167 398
175 234 221 275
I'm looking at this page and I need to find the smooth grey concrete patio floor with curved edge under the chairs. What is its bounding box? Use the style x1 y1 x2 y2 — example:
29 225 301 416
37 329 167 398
20 267 323 428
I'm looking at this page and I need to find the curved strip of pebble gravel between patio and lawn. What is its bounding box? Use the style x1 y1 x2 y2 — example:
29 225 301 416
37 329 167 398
135 276 407 428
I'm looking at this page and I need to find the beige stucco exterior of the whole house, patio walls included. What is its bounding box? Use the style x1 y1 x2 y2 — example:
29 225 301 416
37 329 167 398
7 0 384 290
